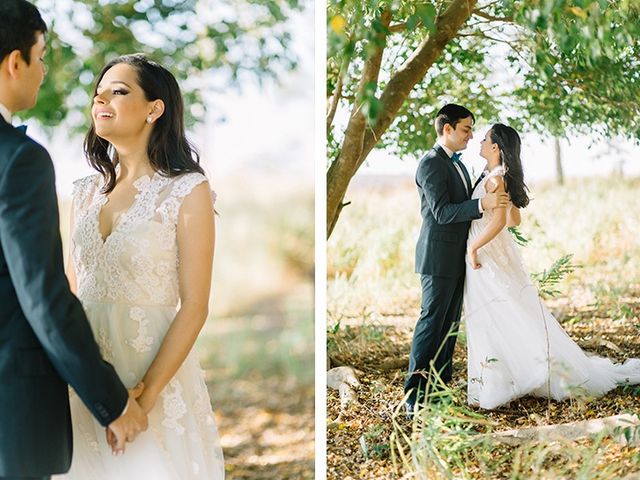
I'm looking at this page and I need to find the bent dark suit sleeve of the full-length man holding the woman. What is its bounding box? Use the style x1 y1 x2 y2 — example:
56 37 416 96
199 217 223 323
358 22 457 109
416 159 482 225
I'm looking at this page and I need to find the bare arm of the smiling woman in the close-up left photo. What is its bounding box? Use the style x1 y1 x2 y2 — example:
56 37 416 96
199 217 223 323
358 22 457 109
138 182 215 413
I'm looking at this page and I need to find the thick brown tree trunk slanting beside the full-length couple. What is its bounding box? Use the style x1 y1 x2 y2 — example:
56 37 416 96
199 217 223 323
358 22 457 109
327 0 477 237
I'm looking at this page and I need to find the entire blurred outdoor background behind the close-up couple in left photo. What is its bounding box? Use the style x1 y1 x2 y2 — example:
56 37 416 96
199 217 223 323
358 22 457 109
22 0 314 479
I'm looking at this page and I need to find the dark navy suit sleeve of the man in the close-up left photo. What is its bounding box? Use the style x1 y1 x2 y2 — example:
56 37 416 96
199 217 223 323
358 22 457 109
0 142 128 426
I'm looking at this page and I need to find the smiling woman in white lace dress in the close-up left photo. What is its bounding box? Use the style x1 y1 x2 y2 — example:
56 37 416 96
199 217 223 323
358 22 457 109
56 55 224 480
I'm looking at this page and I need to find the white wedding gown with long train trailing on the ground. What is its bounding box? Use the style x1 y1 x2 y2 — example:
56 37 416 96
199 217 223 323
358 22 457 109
464 166 640 409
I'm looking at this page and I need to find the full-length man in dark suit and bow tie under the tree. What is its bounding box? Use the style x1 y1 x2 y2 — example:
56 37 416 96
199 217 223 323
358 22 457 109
404 104 508 414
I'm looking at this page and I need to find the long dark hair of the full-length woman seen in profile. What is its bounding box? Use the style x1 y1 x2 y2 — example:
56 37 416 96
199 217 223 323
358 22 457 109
489 123 529 208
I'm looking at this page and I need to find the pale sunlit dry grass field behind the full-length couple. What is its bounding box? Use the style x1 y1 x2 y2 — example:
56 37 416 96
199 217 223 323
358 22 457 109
327 179 640 316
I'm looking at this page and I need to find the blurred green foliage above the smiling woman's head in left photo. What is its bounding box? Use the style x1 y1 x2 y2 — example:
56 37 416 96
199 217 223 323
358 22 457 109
28 0 304 129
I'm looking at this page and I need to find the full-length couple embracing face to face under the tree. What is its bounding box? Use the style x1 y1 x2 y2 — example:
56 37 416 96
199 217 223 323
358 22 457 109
404 104 640 416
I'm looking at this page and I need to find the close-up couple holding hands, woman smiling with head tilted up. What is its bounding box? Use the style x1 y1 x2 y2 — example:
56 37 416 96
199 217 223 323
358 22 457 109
0 0 224 480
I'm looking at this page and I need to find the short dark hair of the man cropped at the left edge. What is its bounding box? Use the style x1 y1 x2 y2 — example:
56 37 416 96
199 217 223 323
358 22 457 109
0 0 47 65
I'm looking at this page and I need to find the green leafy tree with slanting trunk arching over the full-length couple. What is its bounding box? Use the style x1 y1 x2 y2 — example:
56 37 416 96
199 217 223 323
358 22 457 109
327 0 640 235
